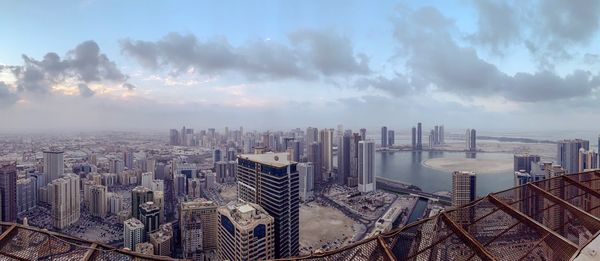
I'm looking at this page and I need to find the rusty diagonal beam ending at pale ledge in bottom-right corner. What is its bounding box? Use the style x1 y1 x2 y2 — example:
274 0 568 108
488 194 578 259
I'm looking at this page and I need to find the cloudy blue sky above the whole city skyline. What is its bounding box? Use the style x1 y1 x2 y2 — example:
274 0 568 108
0 0 600 131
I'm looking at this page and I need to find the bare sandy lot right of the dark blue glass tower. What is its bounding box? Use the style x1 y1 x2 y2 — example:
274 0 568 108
300 202 362 253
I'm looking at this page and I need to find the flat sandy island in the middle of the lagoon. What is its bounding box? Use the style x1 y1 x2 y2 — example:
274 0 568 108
423 158 513 173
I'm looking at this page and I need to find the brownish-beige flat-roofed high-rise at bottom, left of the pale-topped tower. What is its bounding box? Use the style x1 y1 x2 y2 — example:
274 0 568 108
179 198 218 259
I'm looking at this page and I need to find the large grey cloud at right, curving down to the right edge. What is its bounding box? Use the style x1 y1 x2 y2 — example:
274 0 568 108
395 8 600 102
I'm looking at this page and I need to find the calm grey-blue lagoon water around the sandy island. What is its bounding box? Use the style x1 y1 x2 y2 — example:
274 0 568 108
375 151 514 196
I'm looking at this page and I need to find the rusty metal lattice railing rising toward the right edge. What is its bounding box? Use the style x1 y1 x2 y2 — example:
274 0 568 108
290 171 600 261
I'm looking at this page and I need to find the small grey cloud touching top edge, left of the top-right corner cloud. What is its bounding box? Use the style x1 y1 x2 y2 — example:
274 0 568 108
469 0 520 53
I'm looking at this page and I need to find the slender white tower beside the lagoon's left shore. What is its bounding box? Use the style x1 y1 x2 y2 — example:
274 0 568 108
358 140 375 192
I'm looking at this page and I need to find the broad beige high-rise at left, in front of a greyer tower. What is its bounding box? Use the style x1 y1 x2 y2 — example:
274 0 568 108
48 174 81 229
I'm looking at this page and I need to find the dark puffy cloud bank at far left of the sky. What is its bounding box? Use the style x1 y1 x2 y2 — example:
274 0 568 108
5 41 128 94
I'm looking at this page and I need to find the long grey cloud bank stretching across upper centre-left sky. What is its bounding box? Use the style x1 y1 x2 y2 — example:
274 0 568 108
121 30 370 80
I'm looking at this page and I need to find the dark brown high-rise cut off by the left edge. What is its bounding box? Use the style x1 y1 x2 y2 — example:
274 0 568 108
0 161 17 222
